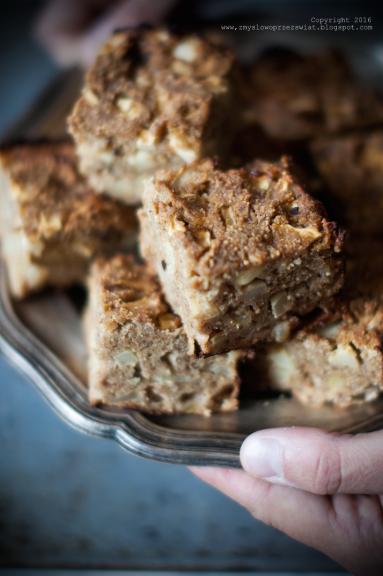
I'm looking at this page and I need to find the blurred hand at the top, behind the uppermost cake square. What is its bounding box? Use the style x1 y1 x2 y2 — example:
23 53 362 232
35 0 175 66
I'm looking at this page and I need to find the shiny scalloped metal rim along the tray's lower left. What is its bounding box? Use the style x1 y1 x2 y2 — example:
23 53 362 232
0 262 244 466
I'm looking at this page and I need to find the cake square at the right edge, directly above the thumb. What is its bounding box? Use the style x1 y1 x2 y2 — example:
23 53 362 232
255 242 383 407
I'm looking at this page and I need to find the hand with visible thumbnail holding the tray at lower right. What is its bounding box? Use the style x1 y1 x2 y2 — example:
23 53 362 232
191 427 383 576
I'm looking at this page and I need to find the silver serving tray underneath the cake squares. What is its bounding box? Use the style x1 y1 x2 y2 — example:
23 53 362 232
0 54 383 467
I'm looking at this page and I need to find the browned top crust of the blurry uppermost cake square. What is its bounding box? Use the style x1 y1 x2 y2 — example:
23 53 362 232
70 29 237 152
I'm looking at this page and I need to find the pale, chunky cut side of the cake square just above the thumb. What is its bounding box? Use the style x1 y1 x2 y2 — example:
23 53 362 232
260 324 383 407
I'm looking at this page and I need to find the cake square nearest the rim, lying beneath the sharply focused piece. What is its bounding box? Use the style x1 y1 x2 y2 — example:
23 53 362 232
85 254 243 415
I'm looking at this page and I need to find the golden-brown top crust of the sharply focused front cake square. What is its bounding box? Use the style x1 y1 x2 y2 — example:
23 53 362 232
152 158 342 275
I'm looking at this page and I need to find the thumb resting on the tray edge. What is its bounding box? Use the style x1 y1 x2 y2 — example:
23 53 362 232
240 427 383 494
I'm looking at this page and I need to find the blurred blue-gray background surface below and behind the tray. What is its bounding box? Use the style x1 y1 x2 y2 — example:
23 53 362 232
0 0 380 572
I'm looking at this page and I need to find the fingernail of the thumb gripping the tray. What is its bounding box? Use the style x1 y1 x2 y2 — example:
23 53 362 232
240 434 283 482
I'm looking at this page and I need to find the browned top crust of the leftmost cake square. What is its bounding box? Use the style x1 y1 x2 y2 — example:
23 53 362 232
0 142 136 243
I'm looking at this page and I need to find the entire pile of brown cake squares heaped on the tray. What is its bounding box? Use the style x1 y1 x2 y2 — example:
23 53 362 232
0 28 383 416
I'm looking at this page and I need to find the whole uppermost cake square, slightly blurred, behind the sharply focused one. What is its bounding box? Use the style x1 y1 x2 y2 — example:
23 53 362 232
69 29 234 204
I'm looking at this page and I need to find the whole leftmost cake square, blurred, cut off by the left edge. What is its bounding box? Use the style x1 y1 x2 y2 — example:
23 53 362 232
0 142 137 298
